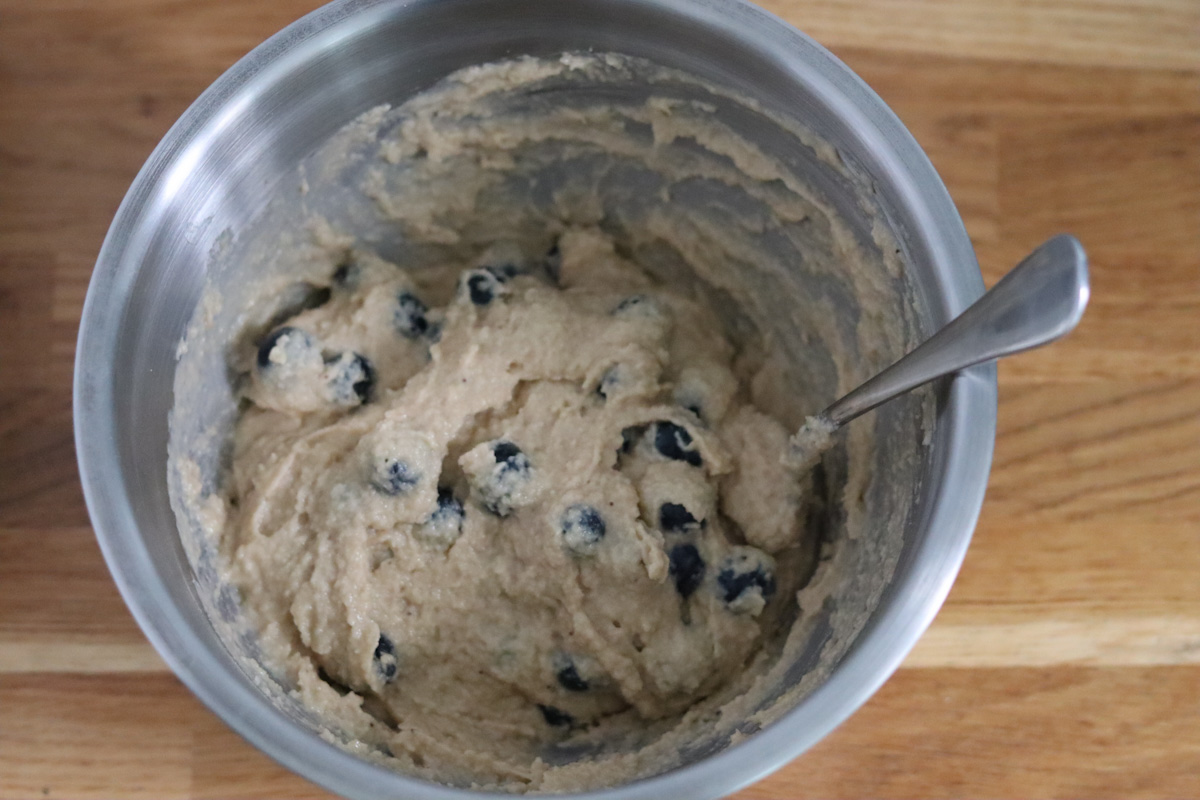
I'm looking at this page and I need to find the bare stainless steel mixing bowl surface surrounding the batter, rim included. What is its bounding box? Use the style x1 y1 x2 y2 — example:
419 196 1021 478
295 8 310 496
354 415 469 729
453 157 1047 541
74 0 996 800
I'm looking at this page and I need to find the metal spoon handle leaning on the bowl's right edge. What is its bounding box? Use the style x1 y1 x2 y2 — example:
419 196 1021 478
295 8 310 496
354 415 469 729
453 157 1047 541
787 234 1091 470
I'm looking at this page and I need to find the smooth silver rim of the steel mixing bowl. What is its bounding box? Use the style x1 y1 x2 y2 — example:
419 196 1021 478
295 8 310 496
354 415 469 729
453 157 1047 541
73 0 997 800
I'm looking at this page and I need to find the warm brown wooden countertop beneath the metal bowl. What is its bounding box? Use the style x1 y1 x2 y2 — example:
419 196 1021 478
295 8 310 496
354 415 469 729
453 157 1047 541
0 0 1200 799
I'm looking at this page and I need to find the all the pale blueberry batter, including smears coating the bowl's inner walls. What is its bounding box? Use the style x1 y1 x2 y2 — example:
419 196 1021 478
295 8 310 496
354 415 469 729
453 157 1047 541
168 54 919 792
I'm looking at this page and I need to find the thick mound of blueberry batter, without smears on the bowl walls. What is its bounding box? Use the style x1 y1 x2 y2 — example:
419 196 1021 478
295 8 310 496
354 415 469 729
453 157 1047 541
228 229 802 780
